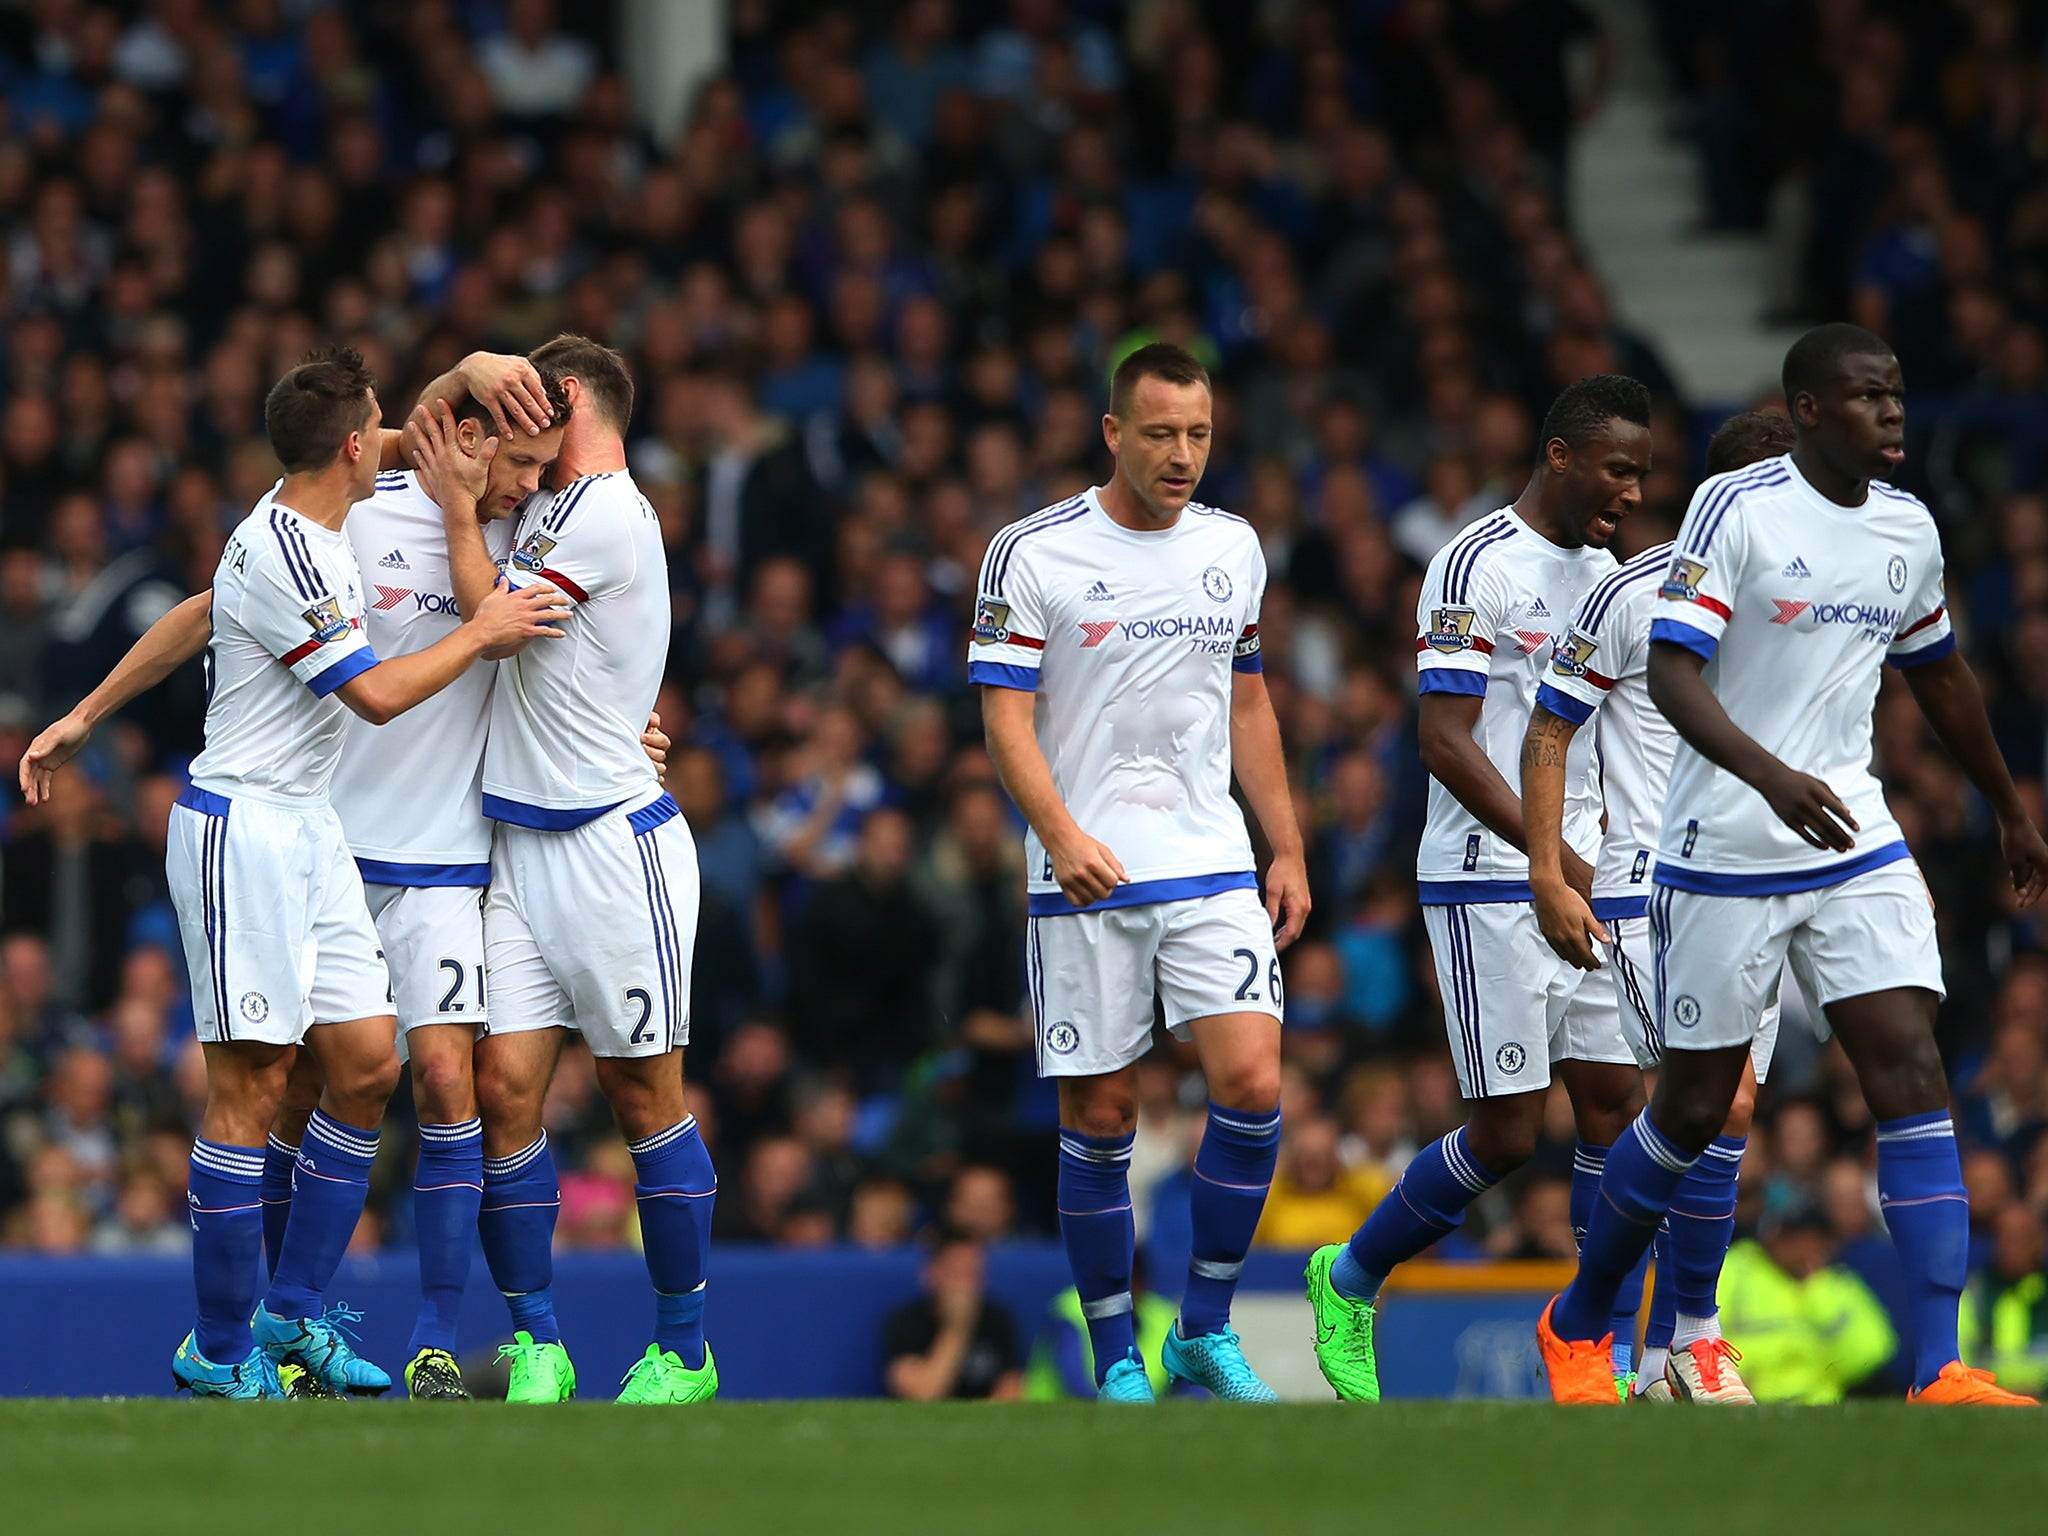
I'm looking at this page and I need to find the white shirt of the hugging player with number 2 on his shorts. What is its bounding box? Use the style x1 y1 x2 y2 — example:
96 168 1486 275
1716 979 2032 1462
483 469 670 831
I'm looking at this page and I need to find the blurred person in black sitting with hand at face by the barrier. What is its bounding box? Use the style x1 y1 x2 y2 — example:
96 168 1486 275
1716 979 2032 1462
883 1235 1022 1403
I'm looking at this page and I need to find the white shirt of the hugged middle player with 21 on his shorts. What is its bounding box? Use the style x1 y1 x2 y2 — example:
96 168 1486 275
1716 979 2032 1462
334 471 512 887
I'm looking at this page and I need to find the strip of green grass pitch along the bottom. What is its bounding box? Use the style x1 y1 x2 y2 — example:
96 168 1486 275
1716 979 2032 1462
12 1401 2048 1536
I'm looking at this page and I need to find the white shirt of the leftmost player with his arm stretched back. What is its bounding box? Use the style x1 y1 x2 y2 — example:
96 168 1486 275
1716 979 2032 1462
193 489 377 807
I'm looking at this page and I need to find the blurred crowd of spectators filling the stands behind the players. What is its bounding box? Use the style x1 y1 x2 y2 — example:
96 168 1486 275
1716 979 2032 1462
0 0 2048 1392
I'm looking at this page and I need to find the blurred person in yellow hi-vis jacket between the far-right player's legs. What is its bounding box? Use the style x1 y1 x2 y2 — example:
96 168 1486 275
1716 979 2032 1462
1720 1204 1896 1403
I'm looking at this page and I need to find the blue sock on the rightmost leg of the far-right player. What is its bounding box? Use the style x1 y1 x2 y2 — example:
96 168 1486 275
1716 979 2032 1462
1878 1110 1970 1391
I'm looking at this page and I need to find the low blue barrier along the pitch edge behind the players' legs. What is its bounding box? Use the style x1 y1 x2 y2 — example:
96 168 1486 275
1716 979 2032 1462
0 1243 1569 1399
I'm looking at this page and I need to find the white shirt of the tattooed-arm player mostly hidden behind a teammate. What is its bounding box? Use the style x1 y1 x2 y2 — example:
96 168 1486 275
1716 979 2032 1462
1536 545 1677 922
